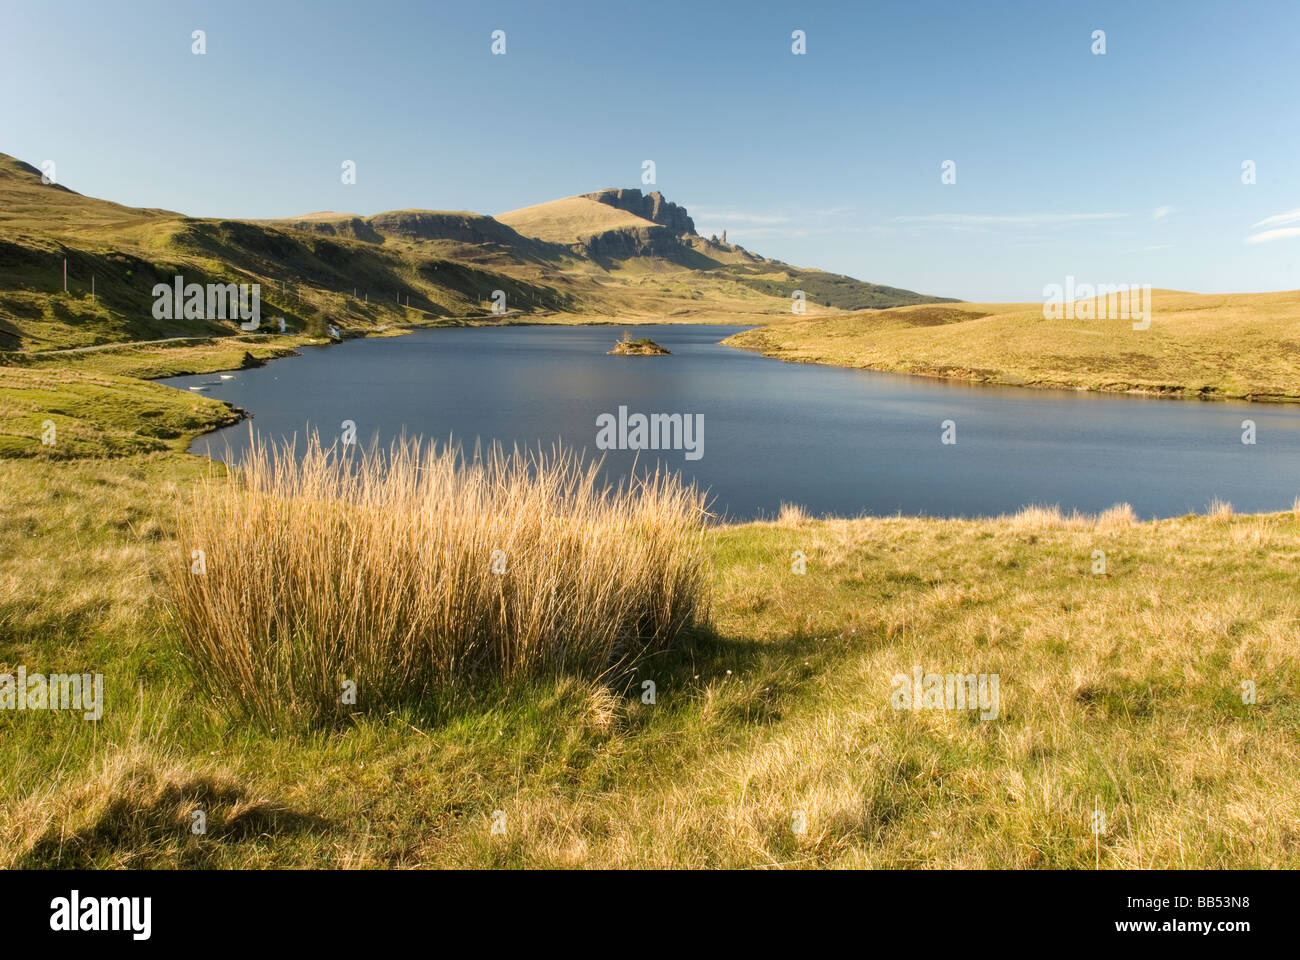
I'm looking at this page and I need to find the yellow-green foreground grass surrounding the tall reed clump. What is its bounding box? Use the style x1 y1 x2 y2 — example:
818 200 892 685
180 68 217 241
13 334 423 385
0 453 1300 869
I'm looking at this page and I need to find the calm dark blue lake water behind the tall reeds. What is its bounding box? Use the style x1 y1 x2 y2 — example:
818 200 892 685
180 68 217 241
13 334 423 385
163 325 1300 519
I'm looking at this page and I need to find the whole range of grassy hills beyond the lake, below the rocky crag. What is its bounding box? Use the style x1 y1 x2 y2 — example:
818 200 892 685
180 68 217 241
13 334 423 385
0 155 956 351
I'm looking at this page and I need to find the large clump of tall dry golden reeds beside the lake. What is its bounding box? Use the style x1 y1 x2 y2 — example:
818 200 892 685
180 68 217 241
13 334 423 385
166 437 709 725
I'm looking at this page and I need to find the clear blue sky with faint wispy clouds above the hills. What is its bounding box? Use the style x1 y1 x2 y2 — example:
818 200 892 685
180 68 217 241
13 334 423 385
0 0 1300 300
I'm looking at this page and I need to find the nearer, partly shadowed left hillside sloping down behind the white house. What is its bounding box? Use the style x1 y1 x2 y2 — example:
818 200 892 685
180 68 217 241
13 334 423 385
0 170 559 350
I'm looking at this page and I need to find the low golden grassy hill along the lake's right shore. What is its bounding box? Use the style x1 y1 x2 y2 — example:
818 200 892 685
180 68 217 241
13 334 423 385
725 290 1300 401
